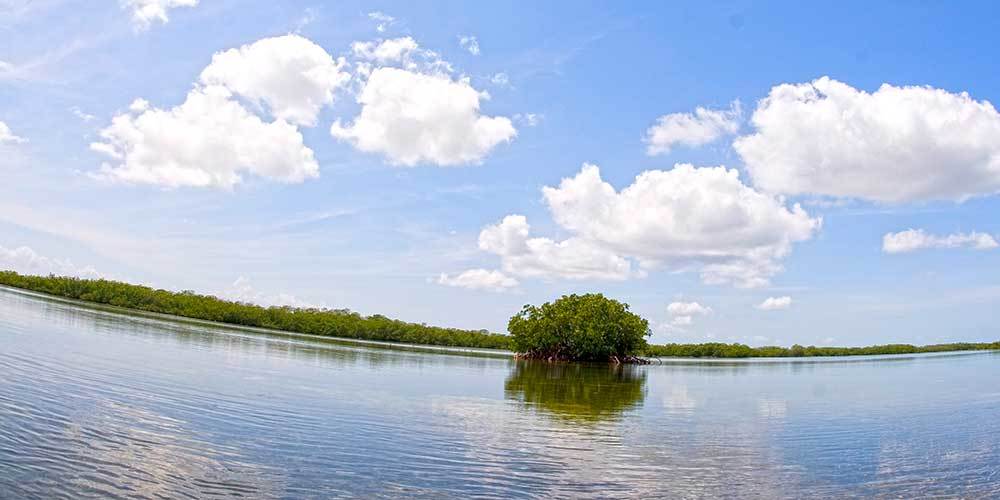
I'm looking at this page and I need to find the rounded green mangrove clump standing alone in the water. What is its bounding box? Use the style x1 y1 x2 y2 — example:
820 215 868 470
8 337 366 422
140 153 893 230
507 294 650 361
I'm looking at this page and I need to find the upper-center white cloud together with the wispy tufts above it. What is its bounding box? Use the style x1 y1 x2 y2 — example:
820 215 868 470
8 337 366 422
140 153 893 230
338 37 517 166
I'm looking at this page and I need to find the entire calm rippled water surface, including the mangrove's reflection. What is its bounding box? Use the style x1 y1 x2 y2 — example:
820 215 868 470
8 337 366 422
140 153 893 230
0 290 1000 498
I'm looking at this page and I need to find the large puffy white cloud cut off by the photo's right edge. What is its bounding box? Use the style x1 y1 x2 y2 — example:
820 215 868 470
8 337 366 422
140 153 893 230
734 77 1000 203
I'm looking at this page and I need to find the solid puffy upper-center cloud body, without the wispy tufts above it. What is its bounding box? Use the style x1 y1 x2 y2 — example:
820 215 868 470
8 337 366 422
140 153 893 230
330 67 517 166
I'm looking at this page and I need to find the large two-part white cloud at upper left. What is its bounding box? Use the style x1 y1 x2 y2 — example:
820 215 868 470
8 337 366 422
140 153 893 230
91 35 340 189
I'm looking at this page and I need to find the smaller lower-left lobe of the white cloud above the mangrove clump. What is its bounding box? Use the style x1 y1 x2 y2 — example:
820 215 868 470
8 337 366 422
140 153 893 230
479 215 633 280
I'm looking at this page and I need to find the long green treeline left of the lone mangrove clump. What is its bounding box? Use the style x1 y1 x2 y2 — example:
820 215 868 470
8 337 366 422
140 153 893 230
0 271 511 349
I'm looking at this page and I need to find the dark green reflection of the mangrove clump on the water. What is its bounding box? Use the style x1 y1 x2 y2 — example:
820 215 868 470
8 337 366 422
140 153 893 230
504 361 646 421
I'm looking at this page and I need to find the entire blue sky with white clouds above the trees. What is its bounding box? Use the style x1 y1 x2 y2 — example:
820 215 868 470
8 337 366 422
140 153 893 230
0 0 1000 345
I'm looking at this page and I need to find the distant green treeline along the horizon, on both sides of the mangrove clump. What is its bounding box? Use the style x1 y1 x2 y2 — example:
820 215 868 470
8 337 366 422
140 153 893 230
0 271 1000 358
